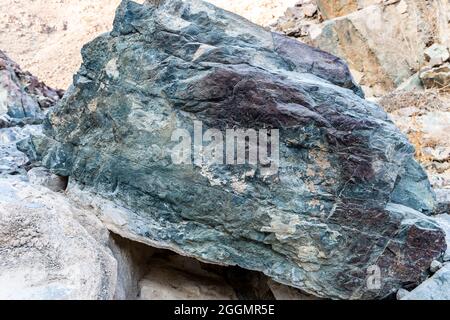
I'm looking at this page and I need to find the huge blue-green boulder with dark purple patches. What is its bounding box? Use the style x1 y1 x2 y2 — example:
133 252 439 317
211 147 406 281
20 0 446 299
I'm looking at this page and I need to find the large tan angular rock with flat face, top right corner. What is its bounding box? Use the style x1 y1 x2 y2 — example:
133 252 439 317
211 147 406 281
275 0 450 96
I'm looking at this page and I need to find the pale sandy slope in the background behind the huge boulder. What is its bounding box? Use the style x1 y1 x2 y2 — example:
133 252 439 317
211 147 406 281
0 0 297 89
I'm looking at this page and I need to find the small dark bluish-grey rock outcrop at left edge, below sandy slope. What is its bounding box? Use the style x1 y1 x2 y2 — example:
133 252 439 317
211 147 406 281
0 51 63 128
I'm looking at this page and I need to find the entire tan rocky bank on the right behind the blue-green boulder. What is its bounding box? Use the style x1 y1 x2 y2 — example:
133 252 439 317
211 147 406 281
274 0 450 202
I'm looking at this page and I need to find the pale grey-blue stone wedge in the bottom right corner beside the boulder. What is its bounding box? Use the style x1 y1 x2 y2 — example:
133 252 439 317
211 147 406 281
402 263 450 300
